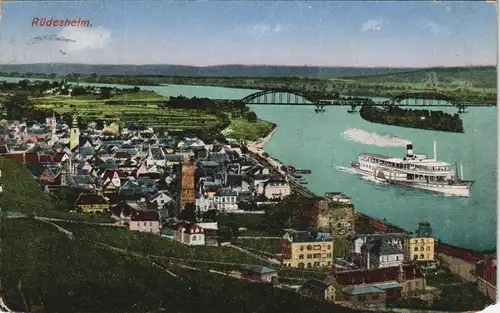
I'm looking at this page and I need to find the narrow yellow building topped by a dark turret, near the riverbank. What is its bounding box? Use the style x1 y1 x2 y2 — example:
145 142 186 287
405 223 435 262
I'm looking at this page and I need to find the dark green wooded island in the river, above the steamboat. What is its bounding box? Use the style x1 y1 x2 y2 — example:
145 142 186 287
359 105 464 133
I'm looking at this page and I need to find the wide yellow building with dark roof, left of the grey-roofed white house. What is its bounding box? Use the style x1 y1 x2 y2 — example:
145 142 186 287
281 228 333 269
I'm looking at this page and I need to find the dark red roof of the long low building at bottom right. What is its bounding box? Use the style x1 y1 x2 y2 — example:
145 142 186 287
335 264 424 286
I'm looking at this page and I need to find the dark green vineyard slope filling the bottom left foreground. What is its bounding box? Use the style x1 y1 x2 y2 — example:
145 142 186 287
0 219 372 313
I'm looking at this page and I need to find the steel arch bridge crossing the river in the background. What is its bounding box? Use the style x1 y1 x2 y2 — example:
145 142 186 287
240 88 496 113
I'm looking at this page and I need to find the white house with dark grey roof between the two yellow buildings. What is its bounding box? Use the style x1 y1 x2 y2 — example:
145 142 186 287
361 238 404 269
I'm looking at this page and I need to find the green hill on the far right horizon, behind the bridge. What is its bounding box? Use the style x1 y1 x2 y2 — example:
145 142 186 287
345 66 497 88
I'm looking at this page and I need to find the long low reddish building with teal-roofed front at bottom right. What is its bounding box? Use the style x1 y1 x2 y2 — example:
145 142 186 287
325 264 426 302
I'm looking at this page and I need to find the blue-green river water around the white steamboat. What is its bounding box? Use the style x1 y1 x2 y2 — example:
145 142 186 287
0 78 497 250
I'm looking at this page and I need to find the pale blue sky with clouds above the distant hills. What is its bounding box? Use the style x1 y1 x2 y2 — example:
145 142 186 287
0 0 498 67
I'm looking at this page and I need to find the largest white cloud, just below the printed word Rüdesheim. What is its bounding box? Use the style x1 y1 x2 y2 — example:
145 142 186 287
58 26 111 51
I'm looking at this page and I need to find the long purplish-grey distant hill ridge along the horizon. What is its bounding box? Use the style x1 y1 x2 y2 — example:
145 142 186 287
0 63 422 78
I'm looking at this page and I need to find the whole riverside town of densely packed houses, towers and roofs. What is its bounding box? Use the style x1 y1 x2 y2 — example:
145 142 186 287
0 92 496 310
